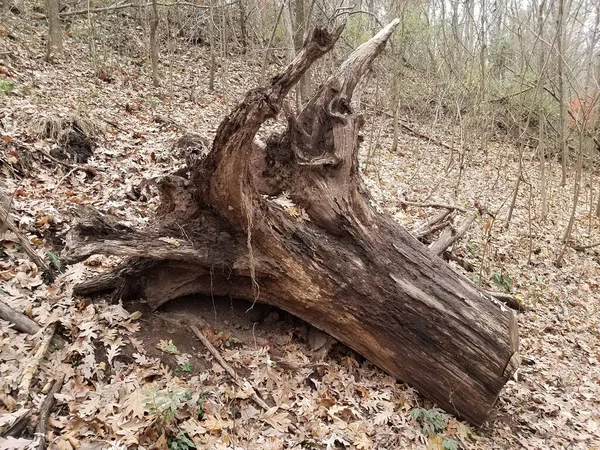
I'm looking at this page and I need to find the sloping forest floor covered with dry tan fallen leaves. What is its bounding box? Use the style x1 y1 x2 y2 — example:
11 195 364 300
0 9 600 450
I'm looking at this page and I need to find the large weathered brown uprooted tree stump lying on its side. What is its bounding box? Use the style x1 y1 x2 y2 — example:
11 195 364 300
65 21 518 424
